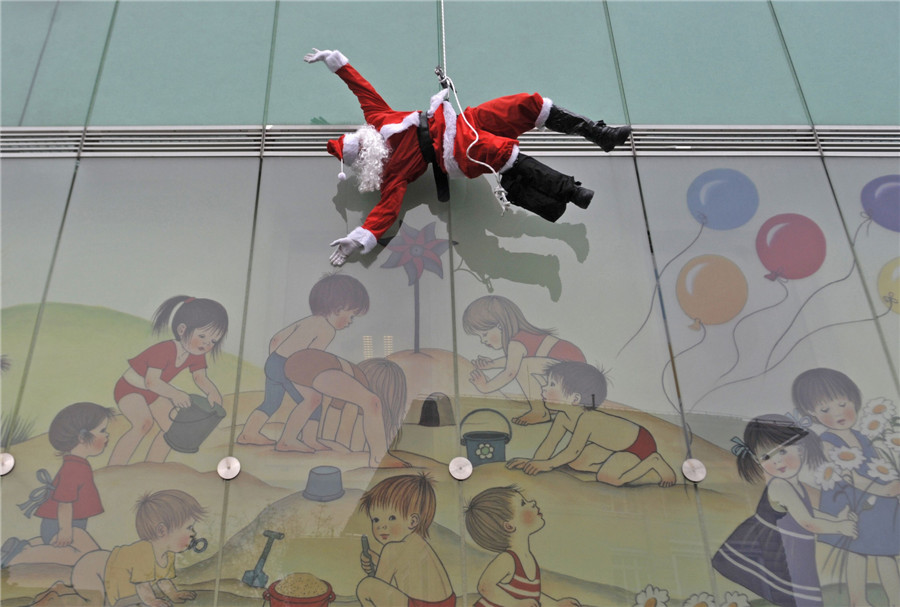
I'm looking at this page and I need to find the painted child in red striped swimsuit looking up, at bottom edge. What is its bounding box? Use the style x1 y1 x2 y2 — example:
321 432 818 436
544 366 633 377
466 487 581 607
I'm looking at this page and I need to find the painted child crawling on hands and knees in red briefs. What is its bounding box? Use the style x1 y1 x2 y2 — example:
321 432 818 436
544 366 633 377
506 362 675 487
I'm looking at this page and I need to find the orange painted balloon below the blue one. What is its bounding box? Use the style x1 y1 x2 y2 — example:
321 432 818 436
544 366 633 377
675 255 747 329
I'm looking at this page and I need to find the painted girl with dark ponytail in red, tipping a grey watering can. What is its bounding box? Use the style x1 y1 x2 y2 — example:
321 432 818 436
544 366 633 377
109 295 228 466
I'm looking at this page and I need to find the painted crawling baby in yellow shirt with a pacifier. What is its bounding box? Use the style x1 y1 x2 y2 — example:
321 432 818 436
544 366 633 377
72 489 206 607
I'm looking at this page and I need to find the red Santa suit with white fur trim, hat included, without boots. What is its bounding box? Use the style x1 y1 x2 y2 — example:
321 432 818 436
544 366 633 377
324 51 553 253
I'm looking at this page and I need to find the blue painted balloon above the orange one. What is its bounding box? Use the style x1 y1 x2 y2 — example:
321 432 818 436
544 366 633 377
687 169 759 230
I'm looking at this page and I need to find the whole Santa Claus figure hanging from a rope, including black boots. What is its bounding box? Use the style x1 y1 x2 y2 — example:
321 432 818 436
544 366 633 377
304 49 631 266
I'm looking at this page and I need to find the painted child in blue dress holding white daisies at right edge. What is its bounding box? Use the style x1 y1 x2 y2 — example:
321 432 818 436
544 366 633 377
792 368 900 607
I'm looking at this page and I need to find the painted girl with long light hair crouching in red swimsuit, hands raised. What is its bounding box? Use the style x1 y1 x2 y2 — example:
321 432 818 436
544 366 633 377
463 295 585 425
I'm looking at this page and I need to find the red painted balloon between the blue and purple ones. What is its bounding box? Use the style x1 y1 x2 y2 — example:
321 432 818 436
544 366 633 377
756 213 825 280
